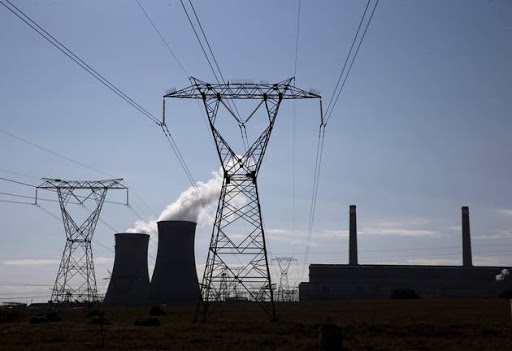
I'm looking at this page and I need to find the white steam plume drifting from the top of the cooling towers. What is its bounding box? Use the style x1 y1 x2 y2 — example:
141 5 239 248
126 169 223 236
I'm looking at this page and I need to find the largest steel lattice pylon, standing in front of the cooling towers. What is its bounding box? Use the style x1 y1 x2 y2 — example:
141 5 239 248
162 77 322 321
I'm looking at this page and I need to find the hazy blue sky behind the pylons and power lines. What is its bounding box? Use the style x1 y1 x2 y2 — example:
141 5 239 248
0 0 512 299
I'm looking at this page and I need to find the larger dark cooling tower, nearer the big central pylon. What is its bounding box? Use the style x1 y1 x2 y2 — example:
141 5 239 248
150 221 199 304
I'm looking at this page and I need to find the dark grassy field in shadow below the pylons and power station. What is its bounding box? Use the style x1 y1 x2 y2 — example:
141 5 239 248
0 299 512 351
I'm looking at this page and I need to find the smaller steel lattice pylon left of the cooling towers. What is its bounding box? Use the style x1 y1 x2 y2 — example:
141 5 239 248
36 178 128 304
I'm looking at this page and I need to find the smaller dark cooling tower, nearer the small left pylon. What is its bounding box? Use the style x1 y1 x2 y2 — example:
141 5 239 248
103 233 149 306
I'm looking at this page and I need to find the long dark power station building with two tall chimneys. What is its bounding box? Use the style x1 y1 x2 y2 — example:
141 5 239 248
299 205 510 301
